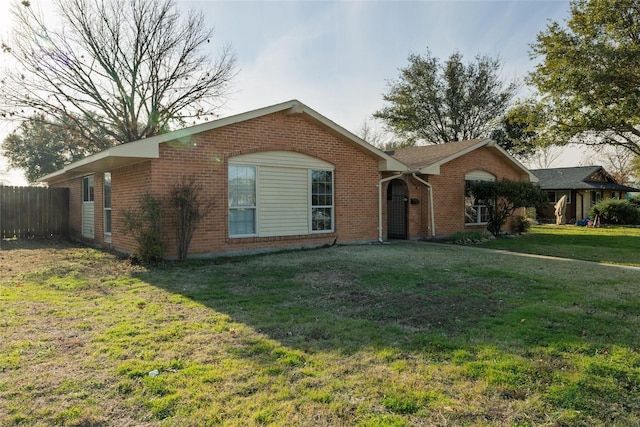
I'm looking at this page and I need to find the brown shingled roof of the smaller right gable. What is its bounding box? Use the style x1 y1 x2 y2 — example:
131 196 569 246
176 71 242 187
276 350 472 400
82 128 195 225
391 138 538 182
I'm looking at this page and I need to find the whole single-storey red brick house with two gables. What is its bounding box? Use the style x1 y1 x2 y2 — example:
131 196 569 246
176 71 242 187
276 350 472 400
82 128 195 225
40 100 535 257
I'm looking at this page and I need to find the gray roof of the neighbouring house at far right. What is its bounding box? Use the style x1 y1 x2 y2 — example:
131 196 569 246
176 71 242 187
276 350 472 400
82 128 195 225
531 166 640 191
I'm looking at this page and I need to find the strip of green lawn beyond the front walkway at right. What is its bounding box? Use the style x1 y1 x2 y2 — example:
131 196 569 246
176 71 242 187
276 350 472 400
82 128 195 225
472 225 640 267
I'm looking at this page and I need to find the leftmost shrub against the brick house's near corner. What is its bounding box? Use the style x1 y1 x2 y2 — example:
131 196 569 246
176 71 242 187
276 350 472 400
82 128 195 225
122 193 165 263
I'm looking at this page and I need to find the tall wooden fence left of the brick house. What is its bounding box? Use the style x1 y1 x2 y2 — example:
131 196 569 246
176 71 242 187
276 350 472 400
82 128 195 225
0 185 69 239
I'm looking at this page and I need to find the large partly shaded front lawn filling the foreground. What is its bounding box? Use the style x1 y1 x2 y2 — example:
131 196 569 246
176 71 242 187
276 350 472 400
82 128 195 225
0 236 640 426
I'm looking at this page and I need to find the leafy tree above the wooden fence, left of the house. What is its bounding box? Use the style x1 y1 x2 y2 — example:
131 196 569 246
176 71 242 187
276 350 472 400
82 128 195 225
2 114 111 182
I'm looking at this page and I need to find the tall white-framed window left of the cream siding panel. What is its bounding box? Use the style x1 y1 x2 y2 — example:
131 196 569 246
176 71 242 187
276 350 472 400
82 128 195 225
229 165 256 236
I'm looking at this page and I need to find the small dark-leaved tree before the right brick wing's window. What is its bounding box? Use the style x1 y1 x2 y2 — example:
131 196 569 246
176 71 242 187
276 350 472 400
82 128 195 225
471 179 548 237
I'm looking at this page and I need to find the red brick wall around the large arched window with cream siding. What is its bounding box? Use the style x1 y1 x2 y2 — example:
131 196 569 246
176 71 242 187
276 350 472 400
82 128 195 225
102 113 380 257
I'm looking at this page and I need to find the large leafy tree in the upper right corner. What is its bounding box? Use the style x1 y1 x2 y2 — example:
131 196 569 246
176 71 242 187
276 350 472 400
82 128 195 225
529 0 640 154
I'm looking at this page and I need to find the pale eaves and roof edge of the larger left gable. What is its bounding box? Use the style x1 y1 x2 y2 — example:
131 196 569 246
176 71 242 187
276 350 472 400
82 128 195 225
38 99 407 183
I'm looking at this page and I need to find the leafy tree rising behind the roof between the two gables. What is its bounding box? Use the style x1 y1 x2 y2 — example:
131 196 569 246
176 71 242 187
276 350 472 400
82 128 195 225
374 52 518 145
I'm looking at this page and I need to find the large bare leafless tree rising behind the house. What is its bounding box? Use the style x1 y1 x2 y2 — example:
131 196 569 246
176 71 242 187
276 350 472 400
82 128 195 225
0 0 236 144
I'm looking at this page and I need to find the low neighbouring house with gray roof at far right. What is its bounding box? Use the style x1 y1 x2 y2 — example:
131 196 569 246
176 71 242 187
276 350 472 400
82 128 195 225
531 166 639 223
